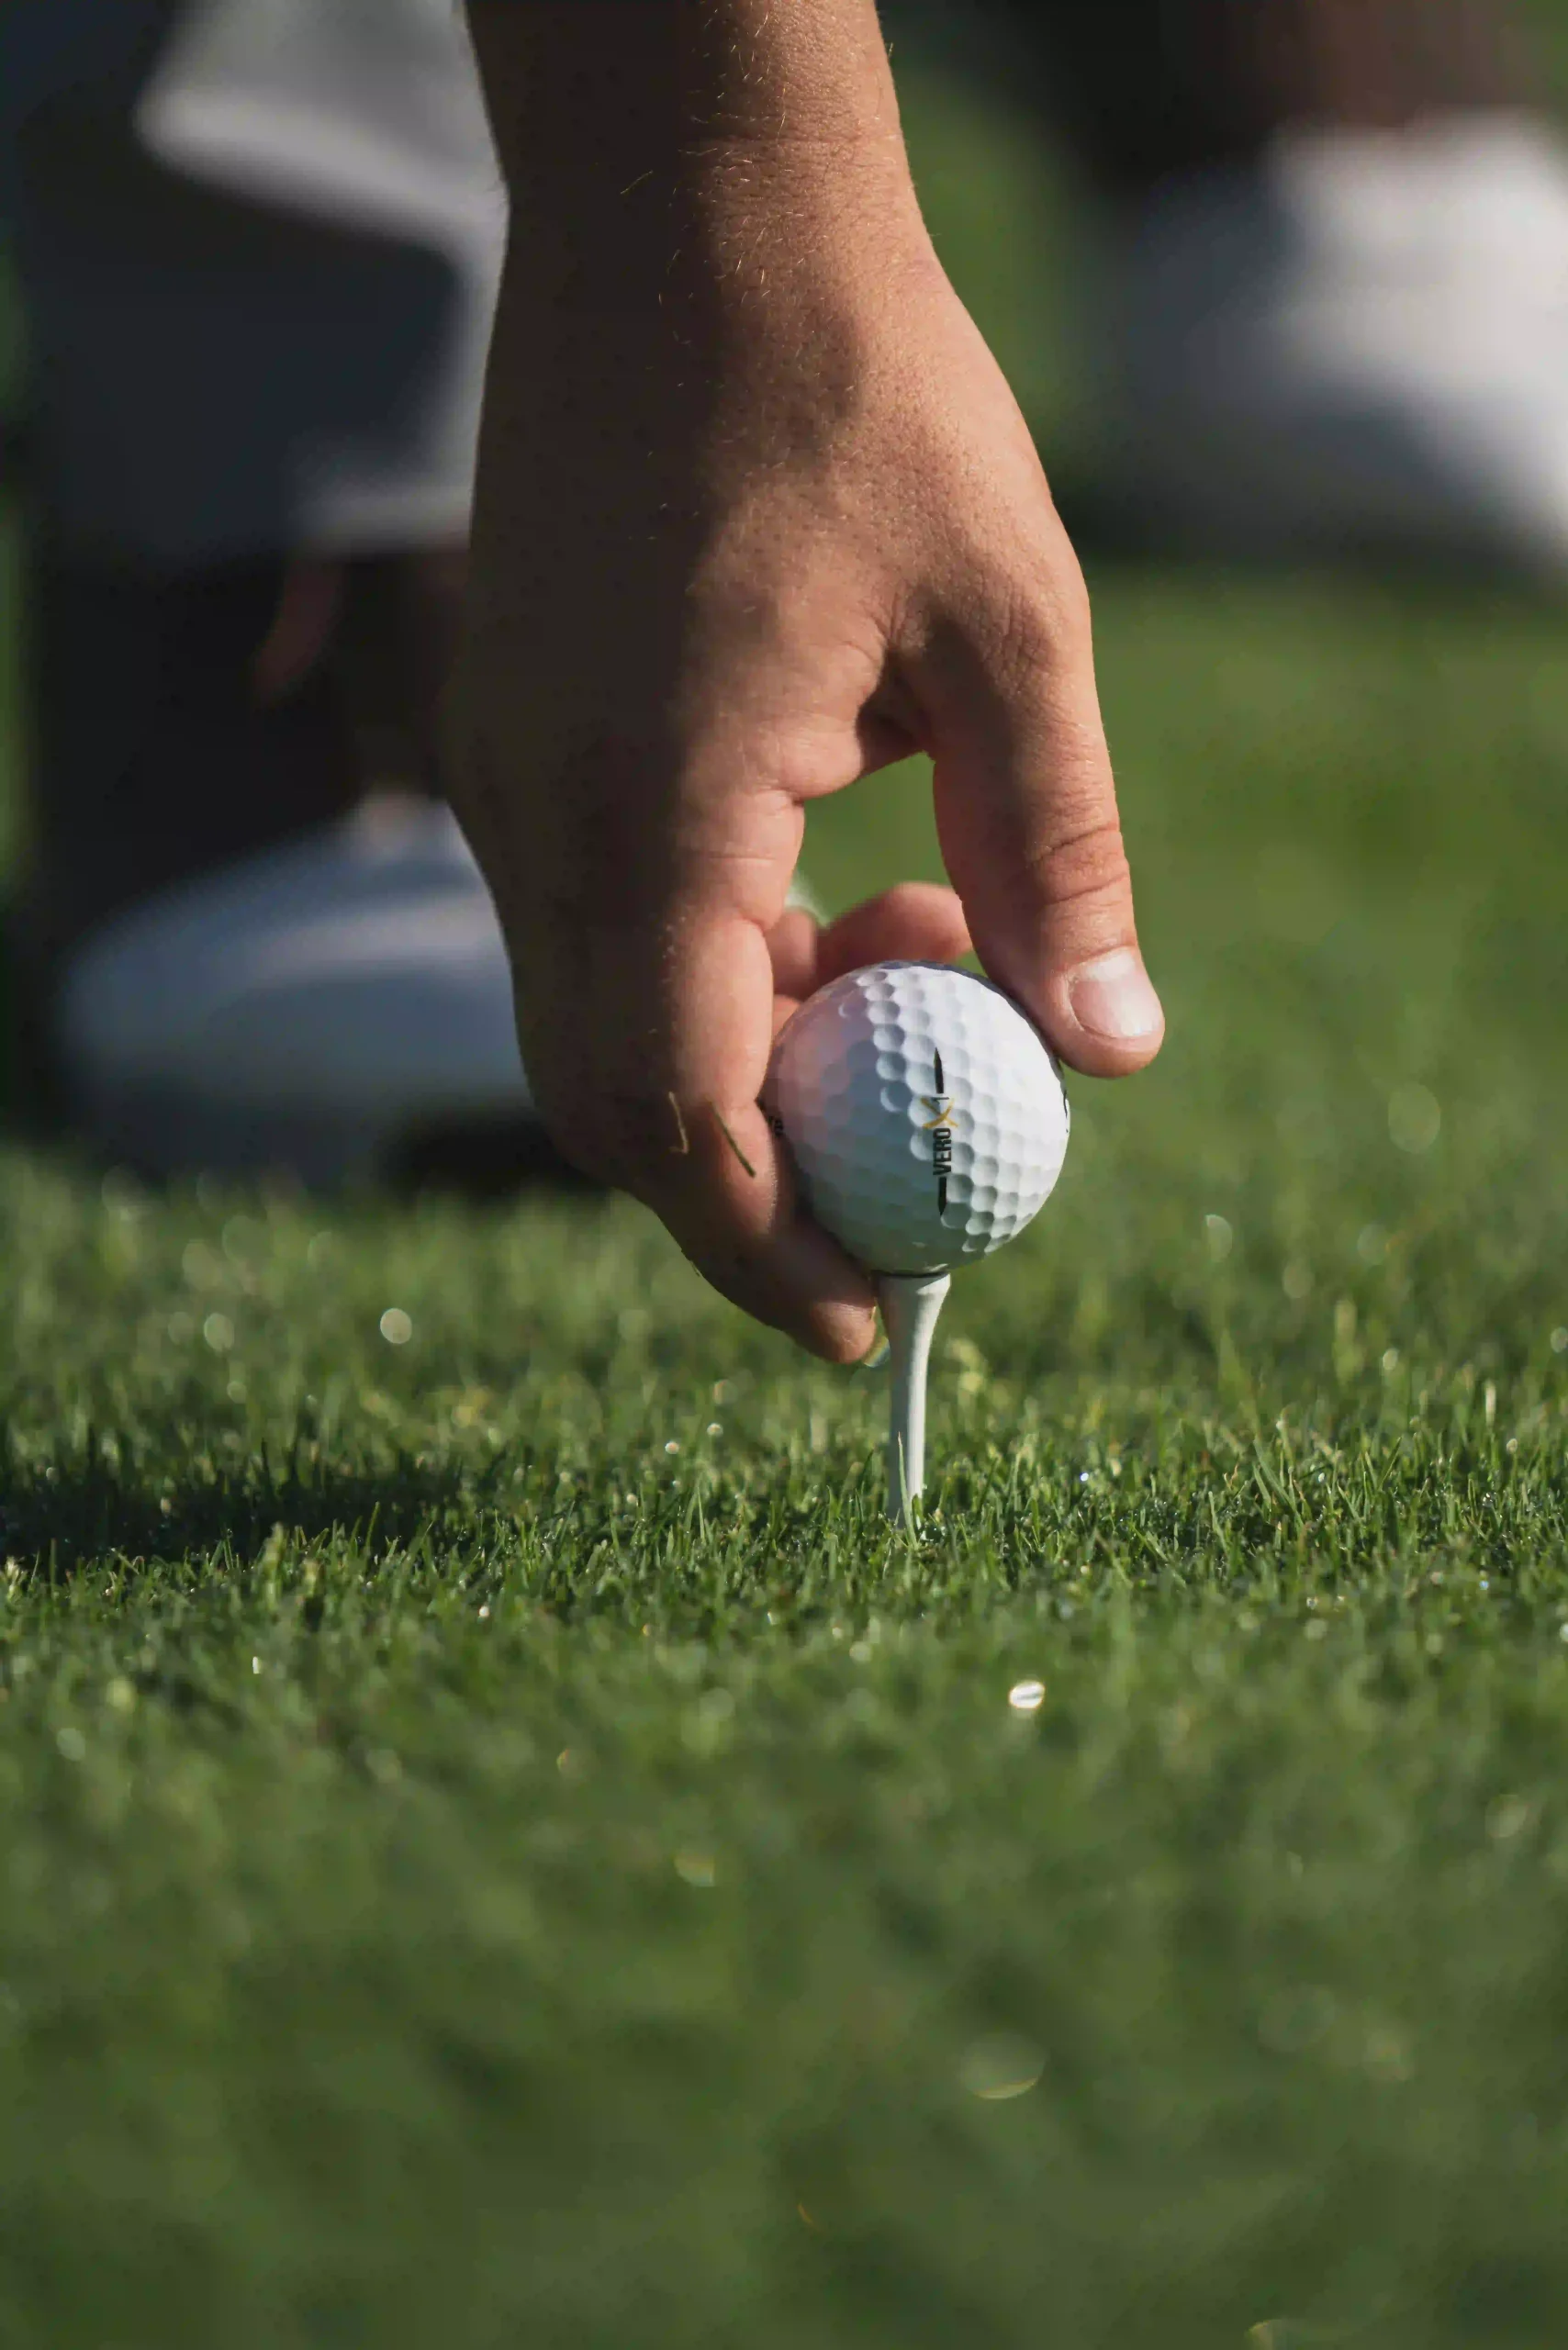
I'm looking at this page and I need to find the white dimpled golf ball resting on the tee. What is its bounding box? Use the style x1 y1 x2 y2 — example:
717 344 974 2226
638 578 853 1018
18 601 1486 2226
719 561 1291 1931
764 964 1070 1274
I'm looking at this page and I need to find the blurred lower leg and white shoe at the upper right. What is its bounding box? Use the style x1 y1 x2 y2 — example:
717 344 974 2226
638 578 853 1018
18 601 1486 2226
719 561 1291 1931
973 0 1568 559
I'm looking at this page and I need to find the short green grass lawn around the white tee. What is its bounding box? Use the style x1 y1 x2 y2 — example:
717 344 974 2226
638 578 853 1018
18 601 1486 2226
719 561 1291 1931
0 45 1568 2350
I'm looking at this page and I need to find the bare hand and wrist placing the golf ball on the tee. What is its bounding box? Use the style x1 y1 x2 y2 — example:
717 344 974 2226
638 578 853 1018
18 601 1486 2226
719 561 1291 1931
454 0 1161 1360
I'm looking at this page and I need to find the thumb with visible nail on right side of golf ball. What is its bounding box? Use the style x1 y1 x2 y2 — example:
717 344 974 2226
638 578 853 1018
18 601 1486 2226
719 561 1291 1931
922 554 1166 1076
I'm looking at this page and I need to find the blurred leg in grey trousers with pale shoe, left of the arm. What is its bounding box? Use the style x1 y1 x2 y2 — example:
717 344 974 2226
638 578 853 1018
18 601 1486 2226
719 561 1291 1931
0 0 538 1180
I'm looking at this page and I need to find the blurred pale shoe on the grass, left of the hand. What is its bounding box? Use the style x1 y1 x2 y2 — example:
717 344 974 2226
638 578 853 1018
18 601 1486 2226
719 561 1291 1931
54 799 816 1187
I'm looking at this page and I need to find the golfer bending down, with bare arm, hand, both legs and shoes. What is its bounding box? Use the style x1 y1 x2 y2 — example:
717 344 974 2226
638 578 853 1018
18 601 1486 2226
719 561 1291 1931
0 0 1563 1354
